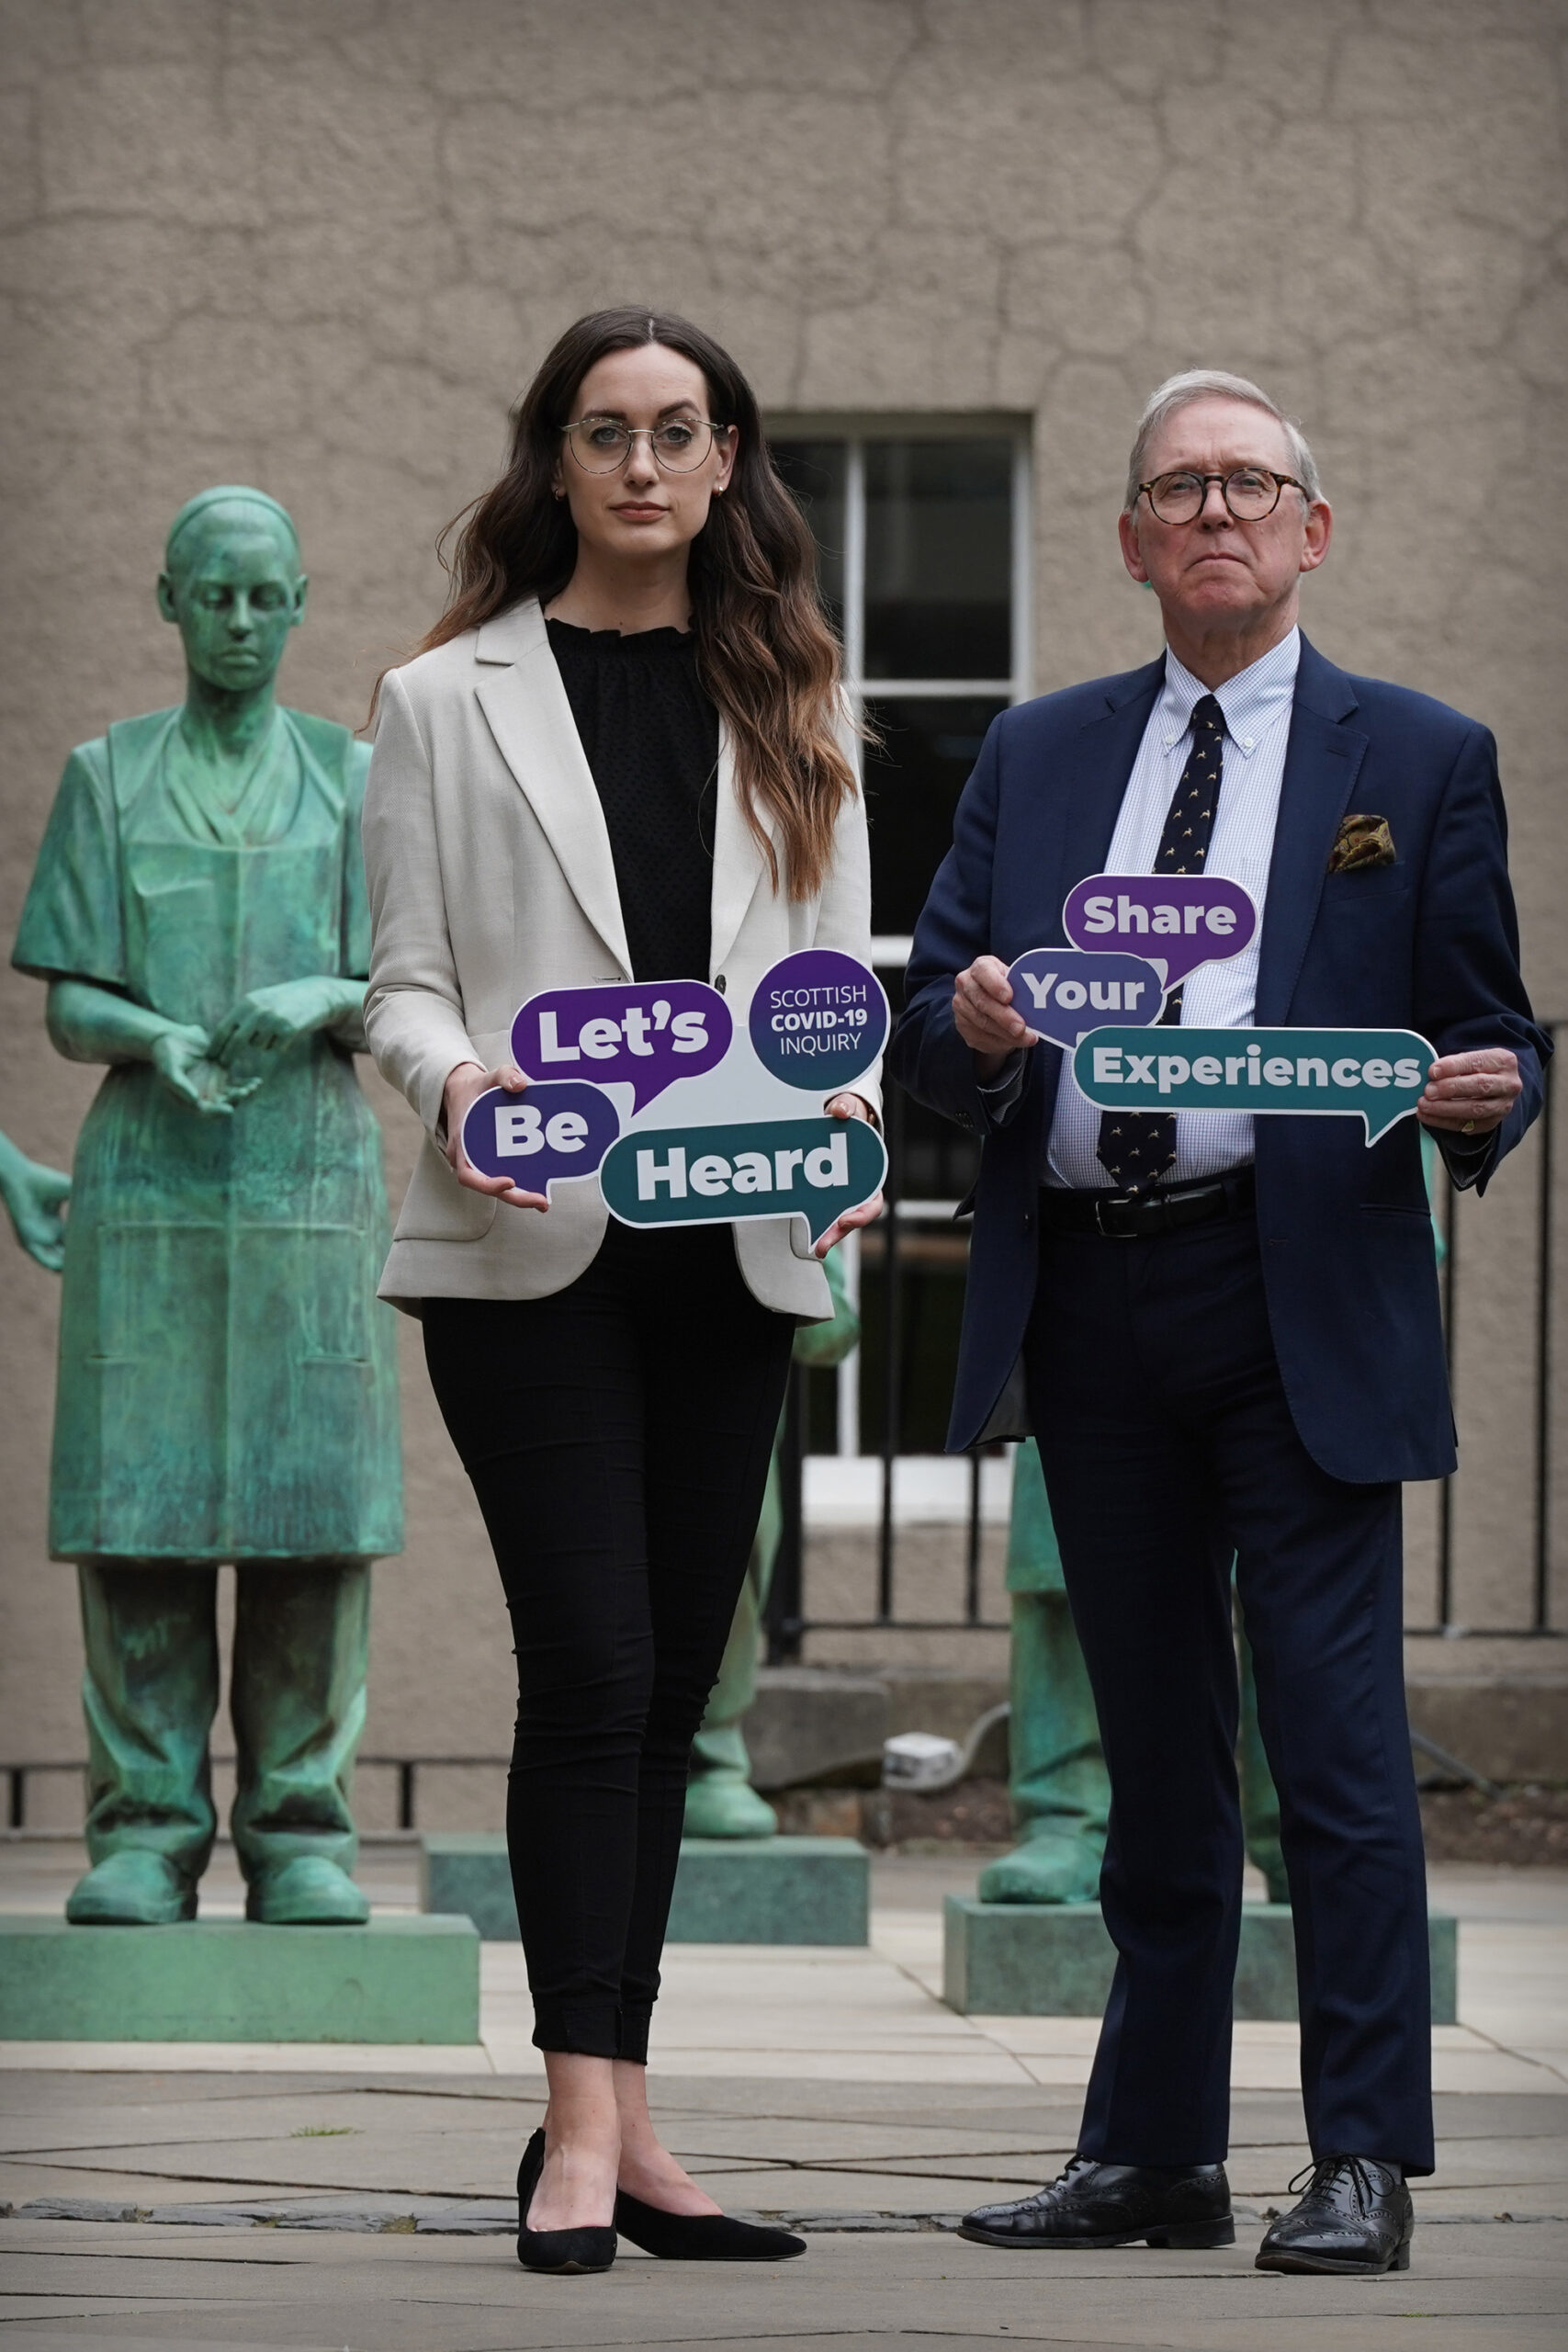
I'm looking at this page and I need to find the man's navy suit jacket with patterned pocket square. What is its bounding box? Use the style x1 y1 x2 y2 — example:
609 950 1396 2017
888 638 1551 1482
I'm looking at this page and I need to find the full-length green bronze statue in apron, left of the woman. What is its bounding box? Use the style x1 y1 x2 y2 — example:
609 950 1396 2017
14 487 402 1924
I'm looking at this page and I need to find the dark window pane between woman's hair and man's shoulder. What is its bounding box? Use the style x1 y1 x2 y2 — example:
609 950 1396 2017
865 694 1006 932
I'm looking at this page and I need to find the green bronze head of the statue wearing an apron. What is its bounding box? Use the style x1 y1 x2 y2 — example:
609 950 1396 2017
157 482 306 694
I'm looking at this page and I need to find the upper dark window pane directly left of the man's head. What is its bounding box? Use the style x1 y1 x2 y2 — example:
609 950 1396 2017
865 440 1013 677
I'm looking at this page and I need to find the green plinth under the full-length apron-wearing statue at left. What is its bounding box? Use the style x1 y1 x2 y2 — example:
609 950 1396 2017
0 1912 479 2041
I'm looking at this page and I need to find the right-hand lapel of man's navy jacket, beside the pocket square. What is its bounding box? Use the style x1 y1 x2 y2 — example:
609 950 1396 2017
1256 638 1368 1028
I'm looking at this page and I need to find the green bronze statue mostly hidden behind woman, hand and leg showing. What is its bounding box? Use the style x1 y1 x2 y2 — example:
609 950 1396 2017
686 1253 861 1837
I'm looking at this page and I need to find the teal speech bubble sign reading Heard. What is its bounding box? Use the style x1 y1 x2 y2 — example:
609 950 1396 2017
600 1117 886 1242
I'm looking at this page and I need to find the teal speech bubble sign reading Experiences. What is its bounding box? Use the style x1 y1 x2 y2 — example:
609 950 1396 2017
1072 1025 1437 1143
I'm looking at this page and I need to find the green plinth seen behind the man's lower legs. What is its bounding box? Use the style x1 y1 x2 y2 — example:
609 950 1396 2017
942 1895 1458 2025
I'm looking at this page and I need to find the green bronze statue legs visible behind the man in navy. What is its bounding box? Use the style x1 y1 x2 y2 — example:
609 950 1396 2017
978 1437 1291 1903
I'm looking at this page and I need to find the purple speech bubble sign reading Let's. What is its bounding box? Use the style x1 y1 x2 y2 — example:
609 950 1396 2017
513 981 733 1110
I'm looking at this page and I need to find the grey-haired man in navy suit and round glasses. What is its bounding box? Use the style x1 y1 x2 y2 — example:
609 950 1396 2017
894 374 1550 2272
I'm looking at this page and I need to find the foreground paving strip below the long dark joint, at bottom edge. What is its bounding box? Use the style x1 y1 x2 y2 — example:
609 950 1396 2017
0 2222 1568 2352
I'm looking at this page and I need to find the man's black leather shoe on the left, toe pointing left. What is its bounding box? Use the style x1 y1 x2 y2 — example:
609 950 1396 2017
959 2157 1236 2248
